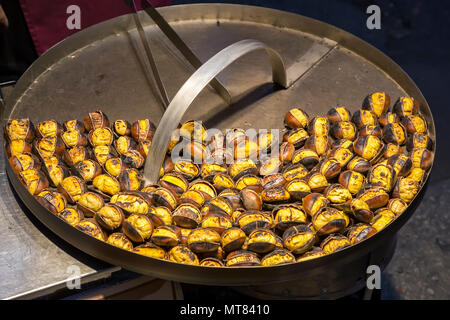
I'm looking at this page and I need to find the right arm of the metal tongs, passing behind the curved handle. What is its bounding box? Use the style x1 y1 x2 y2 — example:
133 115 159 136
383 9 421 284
142 0 231 104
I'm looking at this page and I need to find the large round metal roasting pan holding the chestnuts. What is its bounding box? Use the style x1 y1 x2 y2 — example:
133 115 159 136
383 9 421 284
4 4 436 298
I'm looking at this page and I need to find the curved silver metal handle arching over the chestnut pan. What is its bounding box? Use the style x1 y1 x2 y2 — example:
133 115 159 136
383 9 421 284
144 39 288 184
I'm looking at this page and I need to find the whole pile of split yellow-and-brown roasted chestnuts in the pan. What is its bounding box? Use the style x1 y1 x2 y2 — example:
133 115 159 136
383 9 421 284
4 92 433 267
